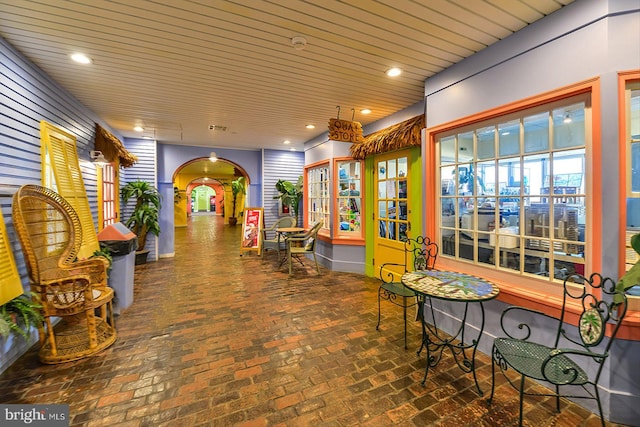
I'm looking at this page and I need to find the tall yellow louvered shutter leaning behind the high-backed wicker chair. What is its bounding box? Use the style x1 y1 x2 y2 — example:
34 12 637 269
40 121 100 259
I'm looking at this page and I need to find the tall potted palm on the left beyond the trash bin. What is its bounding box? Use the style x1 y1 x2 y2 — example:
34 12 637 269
120 180 162 264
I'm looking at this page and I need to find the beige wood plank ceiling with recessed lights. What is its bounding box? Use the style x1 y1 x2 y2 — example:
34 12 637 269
0 0 573 149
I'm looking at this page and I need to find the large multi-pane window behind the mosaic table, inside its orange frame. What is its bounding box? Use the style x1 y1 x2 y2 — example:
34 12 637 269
436 95 590 280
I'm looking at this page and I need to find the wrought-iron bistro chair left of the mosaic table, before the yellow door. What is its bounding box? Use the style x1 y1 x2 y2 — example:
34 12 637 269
376 236 438 349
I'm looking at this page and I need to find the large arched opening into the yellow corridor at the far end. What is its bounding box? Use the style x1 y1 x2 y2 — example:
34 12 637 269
173 157 249 227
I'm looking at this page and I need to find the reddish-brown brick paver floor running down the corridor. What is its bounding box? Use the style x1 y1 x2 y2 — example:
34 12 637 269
0 216 624 427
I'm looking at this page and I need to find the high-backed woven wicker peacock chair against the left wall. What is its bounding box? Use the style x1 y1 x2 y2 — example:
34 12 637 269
13 185 116 363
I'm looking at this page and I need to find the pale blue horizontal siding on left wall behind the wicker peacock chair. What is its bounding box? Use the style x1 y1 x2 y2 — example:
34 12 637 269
0 38 122 372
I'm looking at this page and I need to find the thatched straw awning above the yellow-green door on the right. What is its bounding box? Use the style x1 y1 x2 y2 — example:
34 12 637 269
350 114 425 159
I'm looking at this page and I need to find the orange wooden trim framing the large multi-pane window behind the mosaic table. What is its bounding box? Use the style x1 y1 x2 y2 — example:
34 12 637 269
424 78 640 341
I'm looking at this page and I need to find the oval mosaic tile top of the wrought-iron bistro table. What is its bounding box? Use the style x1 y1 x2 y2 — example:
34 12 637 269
402 270 500 301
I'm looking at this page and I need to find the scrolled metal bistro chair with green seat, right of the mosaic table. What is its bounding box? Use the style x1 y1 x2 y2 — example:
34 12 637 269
488 273 627 427
